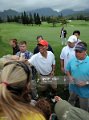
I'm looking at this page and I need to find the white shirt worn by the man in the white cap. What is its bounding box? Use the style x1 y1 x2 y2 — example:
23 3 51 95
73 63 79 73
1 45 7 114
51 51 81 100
60 45 75 71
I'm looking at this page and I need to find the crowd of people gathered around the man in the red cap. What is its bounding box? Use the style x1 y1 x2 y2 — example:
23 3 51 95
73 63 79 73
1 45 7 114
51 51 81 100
0 28 89 120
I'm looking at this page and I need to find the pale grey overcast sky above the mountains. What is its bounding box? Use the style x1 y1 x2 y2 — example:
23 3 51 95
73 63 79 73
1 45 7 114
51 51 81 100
0 0 89 11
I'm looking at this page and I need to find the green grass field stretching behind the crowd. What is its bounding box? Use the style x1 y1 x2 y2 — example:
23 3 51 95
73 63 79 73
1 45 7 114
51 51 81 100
0 21 89 75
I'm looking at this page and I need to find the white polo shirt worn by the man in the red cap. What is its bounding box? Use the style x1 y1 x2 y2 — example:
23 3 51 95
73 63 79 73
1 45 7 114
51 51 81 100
28 51 55 75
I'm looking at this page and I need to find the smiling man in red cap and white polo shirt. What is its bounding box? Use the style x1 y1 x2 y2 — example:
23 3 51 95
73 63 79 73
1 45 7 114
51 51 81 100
28 40 57 95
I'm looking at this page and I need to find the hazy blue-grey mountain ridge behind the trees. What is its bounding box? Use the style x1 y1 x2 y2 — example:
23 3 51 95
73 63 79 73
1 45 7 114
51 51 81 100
0 8 89 18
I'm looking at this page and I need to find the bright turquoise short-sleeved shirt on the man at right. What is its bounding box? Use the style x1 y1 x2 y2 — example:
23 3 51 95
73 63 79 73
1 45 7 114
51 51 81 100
66 56 89 98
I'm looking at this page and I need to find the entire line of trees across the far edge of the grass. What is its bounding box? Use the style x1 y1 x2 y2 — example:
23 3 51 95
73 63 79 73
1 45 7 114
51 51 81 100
0 11 89 27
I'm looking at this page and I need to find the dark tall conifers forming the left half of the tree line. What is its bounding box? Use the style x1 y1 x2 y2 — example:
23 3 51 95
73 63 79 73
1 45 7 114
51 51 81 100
0 11 41 25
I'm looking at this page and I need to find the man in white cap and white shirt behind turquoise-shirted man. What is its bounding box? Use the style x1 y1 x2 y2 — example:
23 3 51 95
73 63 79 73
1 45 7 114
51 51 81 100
60 35 77 73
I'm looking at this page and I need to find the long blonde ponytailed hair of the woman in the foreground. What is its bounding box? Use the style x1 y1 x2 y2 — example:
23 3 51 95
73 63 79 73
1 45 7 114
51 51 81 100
0 62 37 120
